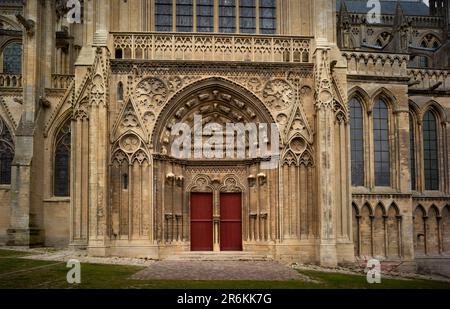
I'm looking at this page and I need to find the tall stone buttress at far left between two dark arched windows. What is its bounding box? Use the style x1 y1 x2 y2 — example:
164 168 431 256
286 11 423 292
7 1 44 246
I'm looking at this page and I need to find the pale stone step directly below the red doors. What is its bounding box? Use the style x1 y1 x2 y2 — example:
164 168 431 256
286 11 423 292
167 251 273 261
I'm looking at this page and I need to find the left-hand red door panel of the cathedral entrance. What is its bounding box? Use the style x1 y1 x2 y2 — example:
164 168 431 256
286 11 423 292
191 193 213 251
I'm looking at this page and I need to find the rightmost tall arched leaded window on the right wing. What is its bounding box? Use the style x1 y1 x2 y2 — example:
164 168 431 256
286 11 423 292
423 111 439 190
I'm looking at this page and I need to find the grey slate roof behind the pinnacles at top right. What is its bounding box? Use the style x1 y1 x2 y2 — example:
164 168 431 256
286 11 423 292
336 0 430 16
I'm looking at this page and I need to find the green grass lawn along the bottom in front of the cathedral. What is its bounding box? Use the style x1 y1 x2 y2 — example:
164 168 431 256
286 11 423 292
0 250 450 289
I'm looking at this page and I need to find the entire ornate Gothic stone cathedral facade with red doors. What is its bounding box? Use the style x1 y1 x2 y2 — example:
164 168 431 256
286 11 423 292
0 0 450 266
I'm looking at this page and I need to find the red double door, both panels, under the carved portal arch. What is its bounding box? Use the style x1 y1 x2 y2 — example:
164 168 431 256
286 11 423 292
191 193 242 251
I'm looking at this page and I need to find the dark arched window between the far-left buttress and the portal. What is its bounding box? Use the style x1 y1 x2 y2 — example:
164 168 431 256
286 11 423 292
53 119 71 196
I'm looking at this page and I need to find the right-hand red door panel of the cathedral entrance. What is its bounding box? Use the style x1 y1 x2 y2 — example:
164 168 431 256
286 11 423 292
220 193 242 251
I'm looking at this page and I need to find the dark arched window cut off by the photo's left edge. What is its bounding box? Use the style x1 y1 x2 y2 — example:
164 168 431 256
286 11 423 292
0 118 14 185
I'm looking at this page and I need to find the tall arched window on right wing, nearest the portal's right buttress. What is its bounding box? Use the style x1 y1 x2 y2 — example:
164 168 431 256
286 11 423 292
350 98 364 186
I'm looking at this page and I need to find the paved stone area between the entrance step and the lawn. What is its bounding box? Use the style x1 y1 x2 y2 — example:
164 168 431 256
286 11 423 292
132 261 303 281
